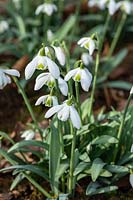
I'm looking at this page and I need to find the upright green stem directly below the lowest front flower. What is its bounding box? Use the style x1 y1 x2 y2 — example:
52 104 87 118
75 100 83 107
68 124 76 194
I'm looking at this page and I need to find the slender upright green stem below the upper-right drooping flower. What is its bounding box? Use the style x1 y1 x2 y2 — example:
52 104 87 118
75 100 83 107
88 52 100 119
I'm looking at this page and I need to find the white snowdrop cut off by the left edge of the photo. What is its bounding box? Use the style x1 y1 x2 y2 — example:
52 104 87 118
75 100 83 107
0 69 20 89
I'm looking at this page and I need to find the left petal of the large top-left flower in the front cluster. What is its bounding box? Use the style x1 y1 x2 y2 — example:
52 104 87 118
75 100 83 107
25 56 38 80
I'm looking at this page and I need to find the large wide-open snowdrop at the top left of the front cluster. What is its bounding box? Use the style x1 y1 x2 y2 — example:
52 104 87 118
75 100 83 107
25 48 60 80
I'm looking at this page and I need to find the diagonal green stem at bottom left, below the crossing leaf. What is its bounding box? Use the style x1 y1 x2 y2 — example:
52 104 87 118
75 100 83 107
24 173 52 199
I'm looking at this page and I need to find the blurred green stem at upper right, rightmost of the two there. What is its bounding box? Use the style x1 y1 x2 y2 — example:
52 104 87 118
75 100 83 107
108 12 127 57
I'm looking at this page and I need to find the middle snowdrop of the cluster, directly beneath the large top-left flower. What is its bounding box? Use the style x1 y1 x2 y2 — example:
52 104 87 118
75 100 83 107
34 73 68 96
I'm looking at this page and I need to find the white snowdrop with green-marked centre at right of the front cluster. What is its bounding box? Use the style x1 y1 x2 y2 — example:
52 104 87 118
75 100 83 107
65 67 92 92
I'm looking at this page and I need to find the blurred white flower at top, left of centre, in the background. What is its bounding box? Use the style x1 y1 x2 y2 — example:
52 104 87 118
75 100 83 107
35 3 57 16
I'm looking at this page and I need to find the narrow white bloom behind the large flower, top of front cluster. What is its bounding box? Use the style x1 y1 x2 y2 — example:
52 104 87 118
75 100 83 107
53 46 66 66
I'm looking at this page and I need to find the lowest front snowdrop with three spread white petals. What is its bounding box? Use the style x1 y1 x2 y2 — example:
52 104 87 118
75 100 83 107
45 99 81 129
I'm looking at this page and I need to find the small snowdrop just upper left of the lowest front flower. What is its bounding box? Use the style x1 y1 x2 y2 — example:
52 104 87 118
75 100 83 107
35 94 58 107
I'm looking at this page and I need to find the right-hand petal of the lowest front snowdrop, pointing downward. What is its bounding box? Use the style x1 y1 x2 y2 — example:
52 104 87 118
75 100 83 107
70 106 81 129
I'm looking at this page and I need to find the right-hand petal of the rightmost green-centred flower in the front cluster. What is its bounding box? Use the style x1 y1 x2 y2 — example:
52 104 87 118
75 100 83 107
81 69 92 92
